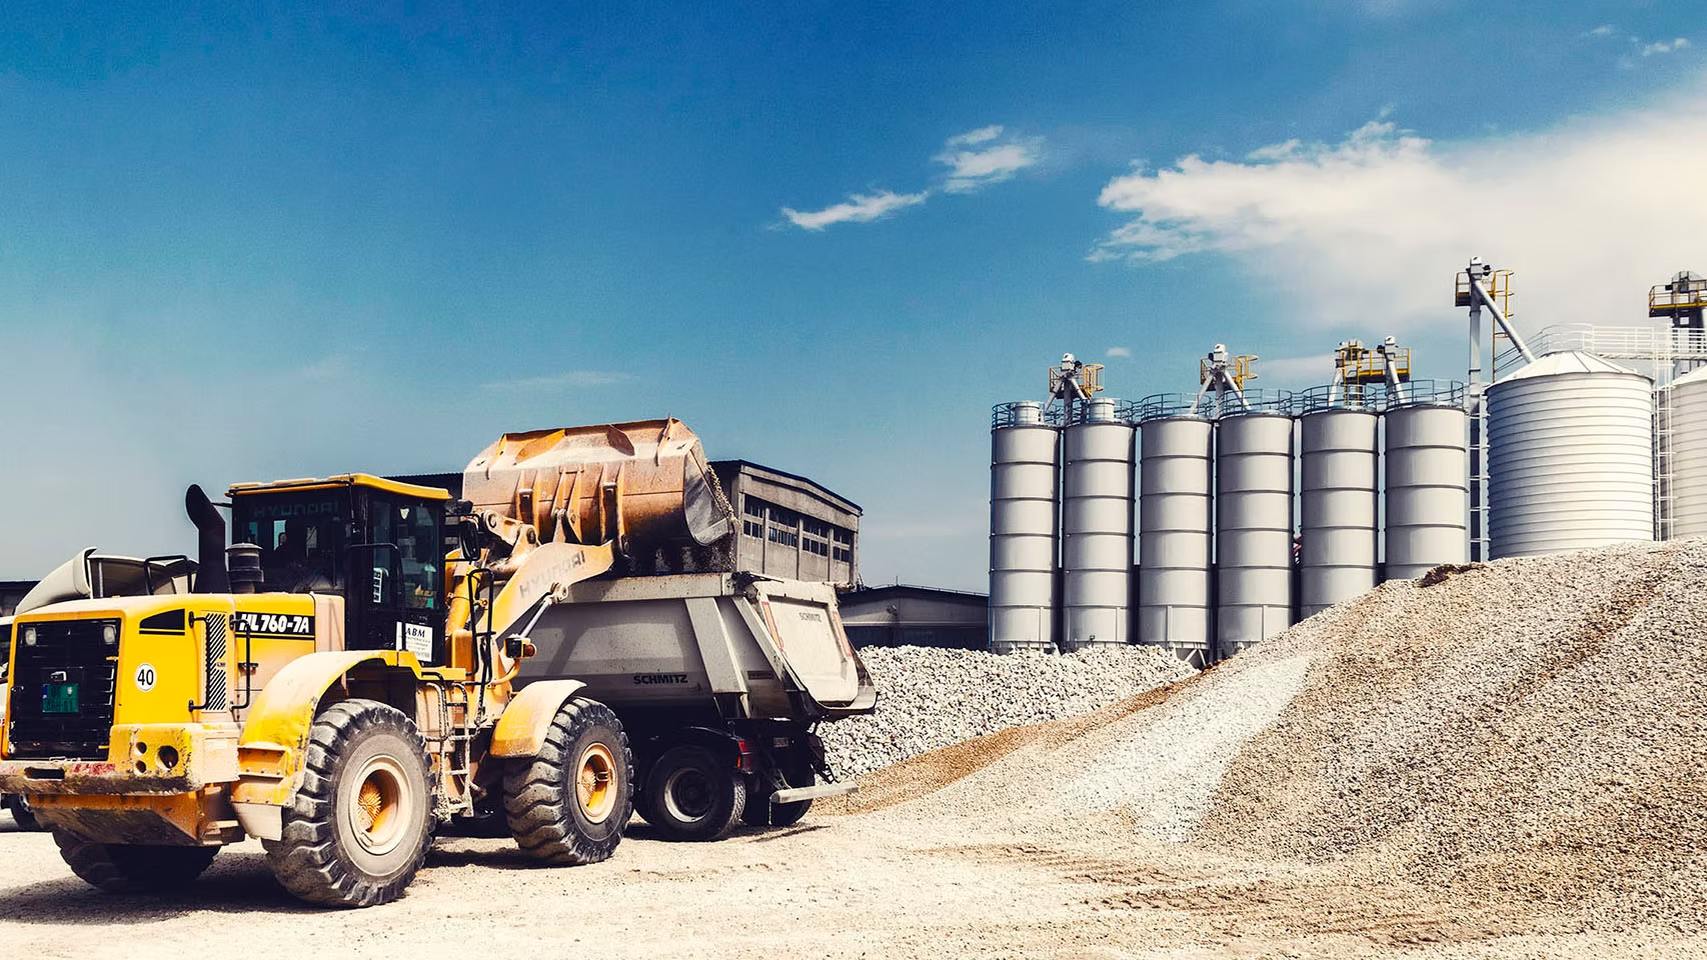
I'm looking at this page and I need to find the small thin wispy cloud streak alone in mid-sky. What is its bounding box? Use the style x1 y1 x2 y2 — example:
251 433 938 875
782 123 1043 232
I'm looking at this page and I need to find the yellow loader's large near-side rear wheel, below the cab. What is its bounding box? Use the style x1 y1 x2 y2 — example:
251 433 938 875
263 700 434 907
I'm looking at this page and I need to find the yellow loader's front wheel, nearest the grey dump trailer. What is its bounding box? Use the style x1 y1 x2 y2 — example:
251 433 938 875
504 697 635 866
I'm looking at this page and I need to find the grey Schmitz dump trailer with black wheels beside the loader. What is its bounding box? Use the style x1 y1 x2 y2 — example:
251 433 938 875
521 574 877 839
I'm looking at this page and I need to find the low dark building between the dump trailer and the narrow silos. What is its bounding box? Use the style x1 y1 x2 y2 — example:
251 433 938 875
840 584 990 649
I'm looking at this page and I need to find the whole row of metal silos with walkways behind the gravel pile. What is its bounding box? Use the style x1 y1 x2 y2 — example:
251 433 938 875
988 260 1707 666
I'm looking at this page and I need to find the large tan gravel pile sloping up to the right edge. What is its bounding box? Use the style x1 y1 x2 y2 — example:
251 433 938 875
873 540 1707 931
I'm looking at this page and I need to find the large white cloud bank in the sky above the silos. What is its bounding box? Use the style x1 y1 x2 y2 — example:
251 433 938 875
1091 82 1707 330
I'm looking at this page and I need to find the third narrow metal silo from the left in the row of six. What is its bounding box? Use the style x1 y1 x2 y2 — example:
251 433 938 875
1137 405 1214 666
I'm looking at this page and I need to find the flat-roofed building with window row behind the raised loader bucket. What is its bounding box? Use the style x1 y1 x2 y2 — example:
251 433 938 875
393 460 864 589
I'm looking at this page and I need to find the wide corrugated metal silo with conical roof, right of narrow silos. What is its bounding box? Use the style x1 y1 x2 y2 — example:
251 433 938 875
1487 350 1654 559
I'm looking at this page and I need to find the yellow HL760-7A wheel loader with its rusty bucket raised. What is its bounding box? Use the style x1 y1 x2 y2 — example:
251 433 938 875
0 420 734 907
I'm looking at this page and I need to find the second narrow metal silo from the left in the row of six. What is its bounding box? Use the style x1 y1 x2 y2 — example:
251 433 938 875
1060 398 1133 649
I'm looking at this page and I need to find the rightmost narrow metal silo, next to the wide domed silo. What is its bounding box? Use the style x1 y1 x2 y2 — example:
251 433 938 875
1383 384 1470 579
